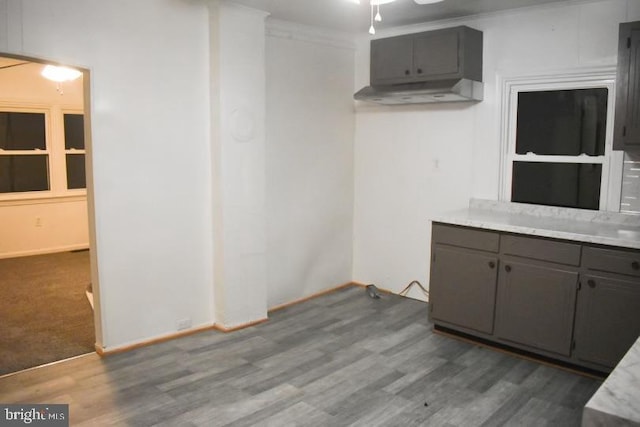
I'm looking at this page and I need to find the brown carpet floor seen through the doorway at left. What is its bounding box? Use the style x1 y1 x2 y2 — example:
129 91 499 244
0 251 95 375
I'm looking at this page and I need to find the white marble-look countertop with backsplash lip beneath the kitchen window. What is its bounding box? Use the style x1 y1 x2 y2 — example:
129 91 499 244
432 199 640 249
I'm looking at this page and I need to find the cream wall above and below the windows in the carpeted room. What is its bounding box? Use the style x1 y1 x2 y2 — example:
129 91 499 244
0 64 89 258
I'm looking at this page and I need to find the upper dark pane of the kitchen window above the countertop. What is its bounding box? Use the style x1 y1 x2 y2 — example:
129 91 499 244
516 88 608 156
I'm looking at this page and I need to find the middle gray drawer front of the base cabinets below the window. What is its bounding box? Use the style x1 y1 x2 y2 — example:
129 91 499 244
500 235 581 266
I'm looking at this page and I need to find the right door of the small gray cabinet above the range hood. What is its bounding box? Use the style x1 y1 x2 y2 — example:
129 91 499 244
413 30 460 77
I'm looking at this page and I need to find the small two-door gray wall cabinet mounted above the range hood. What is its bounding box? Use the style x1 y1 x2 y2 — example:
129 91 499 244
371 26 482 86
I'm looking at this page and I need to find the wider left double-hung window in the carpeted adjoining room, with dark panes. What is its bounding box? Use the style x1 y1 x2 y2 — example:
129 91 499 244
0 111 49 193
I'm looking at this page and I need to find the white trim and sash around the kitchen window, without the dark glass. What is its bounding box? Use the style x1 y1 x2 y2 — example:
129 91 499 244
498 67 623 212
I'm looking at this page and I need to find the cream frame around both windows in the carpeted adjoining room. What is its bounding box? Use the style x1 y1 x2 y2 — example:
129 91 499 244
0 101 87 206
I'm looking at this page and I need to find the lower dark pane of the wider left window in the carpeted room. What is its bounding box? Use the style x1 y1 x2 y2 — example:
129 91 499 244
0 154 49 193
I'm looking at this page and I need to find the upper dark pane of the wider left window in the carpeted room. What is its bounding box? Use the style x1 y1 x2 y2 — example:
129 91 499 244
0 112 46 150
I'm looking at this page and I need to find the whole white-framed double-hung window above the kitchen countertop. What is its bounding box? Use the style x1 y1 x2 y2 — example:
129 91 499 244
501 75 622 211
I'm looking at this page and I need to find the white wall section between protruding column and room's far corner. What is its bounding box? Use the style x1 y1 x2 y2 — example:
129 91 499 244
266 21 354 307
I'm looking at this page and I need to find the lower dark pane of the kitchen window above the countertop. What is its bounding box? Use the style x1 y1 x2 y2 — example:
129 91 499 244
511 162 602 210
